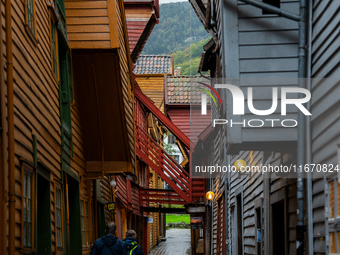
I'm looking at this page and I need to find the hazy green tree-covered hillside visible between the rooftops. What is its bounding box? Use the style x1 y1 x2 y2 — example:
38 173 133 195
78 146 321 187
142 2 210 75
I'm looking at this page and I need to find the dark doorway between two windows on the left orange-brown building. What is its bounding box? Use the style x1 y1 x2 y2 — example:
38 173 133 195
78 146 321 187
37 174 52 255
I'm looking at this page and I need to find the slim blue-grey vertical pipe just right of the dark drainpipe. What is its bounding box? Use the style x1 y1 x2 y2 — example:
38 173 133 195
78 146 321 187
306 1 313 255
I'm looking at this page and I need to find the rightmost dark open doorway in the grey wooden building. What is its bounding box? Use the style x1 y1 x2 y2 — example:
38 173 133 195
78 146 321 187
272 200 286 255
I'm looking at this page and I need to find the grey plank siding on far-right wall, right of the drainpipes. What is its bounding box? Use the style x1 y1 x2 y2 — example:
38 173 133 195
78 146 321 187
311 0 340 254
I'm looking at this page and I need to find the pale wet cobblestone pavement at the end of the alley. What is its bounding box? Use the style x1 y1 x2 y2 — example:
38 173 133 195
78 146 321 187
149 228 191 255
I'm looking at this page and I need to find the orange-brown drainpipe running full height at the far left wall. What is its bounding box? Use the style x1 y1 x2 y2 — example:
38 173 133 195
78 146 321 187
5 0 15 255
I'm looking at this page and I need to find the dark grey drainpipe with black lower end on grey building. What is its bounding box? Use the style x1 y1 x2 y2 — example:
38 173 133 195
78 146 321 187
296 0 307 255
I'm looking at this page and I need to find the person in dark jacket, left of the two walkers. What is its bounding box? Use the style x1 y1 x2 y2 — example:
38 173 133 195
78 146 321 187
90 222 127 255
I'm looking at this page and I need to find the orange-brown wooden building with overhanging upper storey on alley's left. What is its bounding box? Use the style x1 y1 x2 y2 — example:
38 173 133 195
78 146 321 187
0 0 155 255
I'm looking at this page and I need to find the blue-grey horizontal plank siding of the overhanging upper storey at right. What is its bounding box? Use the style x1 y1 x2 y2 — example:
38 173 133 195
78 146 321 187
212 0 299 154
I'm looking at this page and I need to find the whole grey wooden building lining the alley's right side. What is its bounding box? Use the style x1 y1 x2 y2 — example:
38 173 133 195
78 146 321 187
190 0 340 255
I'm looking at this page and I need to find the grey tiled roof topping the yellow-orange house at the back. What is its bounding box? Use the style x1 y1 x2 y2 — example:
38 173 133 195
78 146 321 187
133 55 172 74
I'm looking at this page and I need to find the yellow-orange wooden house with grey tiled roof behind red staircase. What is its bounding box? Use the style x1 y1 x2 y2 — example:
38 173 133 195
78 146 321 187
133 55 173 252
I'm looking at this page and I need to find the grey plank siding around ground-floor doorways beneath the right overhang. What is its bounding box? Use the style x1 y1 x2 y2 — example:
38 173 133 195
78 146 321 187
224 152 297 254
